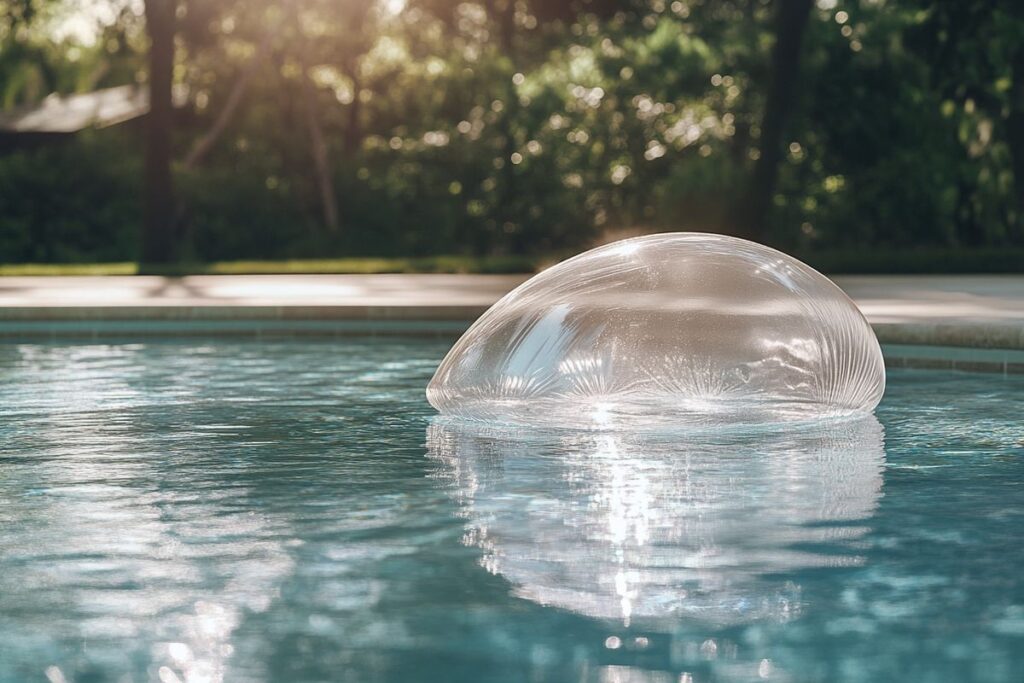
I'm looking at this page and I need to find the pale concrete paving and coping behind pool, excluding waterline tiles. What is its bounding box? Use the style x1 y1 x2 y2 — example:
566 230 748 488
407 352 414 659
0 274 1024 349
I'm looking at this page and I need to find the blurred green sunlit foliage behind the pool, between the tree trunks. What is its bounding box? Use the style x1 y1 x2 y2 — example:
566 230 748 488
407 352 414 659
0 0 1024 269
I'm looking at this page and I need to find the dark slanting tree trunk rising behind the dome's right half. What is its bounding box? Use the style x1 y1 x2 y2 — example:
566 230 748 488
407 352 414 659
733 0 814 240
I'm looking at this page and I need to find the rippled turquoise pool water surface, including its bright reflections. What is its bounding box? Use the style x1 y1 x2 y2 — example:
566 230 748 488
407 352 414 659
0 339 1024 683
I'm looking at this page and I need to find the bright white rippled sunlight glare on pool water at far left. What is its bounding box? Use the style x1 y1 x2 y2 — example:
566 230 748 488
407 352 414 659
0 345 294 683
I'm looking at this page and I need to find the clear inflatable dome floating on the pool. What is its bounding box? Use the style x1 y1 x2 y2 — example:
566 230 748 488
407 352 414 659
427 232 885 428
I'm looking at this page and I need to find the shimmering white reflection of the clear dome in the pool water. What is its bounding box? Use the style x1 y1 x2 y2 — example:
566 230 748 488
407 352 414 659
427 417 884 626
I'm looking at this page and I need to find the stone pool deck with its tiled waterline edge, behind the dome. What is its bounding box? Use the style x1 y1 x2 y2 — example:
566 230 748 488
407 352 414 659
0 274 1024 372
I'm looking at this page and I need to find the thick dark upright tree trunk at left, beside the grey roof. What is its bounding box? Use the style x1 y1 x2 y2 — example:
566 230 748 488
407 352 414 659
140 0 175 265
